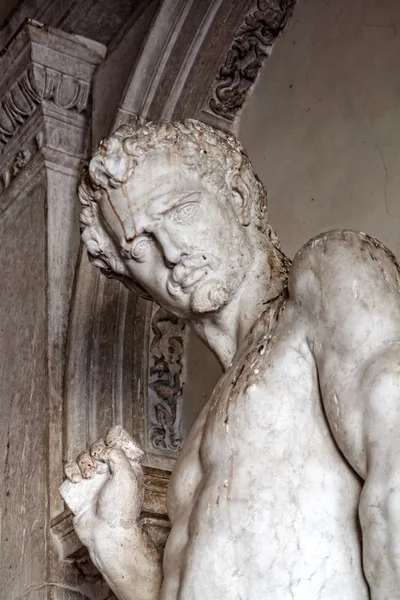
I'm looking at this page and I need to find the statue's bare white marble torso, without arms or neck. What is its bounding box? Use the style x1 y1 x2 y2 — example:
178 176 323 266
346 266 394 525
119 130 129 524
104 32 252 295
163 308 368 600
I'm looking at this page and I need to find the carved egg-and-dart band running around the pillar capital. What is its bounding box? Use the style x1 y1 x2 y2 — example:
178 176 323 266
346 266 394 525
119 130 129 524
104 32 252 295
0 64 90 150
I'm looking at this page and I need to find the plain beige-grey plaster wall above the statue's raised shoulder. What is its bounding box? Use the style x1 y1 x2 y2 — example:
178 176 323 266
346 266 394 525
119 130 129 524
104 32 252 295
239 0 400 257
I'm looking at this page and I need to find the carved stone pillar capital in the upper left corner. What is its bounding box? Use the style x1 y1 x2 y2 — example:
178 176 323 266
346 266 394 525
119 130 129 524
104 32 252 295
0 21 105 185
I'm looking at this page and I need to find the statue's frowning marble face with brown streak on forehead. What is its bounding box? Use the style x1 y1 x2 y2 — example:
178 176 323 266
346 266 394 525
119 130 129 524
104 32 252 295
100 151 253 318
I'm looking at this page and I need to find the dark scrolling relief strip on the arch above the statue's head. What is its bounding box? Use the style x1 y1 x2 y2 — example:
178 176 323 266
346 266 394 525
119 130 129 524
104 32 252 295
208 0 296 121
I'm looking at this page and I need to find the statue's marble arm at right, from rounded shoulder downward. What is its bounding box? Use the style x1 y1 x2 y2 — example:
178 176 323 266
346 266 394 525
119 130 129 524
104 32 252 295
292 231 400 600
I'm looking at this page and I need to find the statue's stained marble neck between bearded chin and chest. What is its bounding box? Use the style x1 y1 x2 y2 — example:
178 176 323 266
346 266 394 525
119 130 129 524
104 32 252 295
192 245 290 371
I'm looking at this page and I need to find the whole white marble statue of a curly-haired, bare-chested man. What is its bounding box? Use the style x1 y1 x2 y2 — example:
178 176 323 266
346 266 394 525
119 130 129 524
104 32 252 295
61 120 400 600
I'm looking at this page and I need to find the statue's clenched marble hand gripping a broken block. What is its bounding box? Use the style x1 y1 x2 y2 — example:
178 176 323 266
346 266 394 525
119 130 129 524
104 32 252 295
60 426 144 556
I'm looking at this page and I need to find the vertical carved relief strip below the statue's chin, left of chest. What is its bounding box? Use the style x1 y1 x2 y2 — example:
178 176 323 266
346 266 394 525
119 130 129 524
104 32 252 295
148 307 187 456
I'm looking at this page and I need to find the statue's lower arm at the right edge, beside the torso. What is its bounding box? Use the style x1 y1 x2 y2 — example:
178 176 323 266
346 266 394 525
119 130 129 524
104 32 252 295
360 344 400 600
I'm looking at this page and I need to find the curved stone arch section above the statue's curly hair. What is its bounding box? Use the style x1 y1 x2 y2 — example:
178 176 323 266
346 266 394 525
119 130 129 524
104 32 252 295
114 0 296 133
